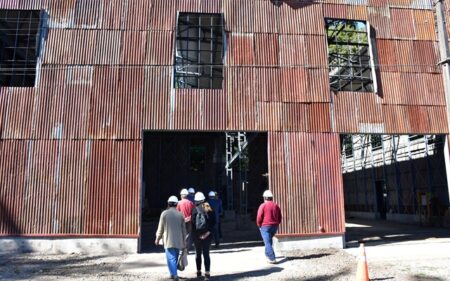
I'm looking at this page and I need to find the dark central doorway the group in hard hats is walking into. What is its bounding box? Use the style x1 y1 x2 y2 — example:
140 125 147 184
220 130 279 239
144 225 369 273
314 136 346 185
140 132 268 252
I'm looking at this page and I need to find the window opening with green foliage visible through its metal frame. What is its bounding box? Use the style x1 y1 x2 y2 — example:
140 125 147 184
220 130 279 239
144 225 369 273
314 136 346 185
325 19 375 92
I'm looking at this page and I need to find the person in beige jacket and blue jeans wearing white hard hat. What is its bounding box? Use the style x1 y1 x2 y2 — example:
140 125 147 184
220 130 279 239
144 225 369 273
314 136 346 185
155 196 186 281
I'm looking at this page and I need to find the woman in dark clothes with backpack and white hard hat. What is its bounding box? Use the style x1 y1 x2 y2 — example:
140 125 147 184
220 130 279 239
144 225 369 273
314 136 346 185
191 189 216 280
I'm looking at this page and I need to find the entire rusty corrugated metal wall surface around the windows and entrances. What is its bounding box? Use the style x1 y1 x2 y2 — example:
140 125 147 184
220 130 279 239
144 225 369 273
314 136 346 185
0 0 447 236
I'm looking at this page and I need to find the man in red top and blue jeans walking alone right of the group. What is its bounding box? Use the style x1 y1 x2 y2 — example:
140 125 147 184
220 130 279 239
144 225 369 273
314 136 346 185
256 190 281 263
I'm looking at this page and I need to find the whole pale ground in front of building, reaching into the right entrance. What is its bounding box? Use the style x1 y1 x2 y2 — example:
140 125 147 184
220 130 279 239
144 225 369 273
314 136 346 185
0 220 450 281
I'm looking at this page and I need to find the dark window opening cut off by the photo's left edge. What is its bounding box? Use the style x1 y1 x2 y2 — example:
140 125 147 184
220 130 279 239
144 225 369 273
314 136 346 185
0 10 41 87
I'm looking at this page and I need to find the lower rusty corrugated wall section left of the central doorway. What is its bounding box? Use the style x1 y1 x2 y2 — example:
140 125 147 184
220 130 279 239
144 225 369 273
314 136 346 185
0 140 140 237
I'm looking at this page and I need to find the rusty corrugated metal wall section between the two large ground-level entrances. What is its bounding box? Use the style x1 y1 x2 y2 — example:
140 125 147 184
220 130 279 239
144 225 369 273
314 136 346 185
268 132 345 236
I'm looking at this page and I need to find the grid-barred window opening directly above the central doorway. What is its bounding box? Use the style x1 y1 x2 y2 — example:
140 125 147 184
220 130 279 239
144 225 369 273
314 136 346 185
175 13 224 89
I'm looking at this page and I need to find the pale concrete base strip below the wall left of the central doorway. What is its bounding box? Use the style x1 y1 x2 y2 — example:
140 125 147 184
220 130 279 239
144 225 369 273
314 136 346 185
0 238 138 254
